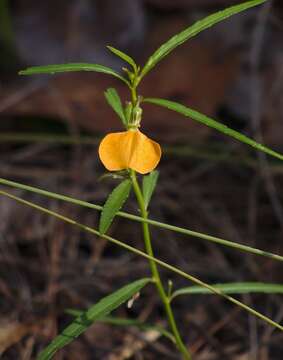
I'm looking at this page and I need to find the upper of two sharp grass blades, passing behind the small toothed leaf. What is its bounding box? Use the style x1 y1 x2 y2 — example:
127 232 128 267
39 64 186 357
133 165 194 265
0 178 283 262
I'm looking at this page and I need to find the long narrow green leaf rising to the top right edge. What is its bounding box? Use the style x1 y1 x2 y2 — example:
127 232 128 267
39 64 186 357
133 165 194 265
141 0 266 78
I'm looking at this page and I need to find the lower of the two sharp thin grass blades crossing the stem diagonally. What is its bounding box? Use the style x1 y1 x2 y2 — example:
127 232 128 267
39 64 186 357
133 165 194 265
0 191 283 331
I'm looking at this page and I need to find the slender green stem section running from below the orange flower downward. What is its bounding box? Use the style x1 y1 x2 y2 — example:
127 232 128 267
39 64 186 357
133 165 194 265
130 170 191 360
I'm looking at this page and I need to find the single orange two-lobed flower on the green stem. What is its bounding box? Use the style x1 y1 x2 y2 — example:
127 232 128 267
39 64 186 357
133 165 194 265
98 129 161 174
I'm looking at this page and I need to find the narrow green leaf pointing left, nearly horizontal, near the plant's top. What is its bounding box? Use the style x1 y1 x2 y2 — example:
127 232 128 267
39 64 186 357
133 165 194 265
19 63 128 83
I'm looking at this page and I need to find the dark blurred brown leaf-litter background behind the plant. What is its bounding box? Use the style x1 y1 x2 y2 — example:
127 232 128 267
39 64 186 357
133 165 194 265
0 0 283 360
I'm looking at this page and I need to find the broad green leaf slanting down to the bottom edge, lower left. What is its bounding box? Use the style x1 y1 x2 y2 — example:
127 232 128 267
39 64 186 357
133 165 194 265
38 278 151 360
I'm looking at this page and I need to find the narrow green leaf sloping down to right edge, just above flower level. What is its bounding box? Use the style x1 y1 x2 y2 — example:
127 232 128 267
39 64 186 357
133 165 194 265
143 98 283 160
